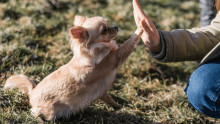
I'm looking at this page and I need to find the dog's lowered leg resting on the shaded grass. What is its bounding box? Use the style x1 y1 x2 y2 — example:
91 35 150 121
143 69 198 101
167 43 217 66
101 92 121 109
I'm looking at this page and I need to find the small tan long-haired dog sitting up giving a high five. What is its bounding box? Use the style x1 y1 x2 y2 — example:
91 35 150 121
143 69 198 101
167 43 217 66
4 16 142 120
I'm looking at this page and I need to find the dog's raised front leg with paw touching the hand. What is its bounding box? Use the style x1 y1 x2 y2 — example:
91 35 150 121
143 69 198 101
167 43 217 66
116 28 143 67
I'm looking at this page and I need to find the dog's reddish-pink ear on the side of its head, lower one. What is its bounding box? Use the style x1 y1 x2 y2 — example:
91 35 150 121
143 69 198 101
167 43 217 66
70 26 88 39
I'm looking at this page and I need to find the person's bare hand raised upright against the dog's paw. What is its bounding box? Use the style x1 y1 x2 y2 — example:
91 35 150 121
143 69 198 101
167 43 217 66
133 0 162 52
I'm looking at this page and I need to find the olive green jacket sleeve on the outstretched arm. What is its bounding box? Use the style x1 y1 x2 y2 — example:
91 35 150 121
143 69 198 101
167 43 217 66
150 12 220 62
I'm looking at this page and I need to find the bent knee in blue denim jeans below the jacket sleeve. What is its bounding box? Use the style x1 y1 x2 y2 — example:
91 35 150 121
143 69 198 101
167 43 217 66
185 59 220 118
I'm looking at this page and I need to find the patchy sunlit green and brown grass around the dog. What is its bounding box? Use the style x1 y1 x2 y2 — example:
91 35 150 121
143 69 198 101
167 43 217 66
0 0 220 124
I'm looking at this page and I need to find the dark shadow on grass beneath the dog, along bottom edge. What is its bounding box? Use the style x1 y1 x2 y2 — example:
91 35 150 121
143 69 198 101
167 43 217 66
52 108 160 124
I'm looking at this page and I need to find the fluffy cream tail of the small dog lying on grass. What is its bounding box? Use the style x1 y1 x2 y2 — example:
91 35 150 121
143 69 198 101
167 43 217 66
4 75 36 95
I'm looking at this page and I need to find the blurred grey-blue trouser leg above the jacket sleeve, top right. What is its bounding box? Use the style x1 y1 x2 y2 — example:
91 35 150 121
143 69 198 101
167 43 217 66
199 0 215 27
